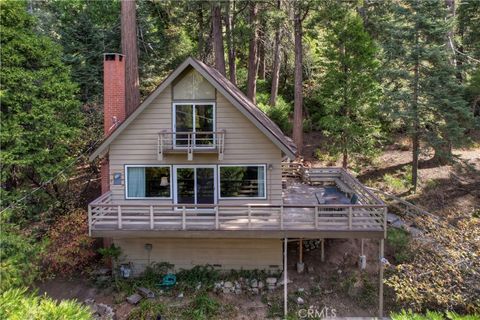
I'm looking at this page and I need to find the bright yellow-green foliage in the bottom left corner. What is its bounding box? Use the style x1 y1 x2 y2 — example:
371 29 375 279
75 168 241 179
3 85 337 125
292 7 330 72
0 288 92 320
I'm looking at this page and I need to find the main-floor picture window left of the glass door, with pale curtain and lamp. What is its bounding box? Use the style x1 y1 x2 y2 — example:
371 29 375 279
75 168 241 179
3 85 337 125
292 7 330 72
126 166 172 199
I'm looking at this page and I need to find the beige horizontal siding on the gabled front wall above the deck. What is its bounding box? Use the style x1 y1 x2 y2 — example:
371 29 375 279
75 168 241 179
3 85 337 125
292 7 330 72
109 87 282 204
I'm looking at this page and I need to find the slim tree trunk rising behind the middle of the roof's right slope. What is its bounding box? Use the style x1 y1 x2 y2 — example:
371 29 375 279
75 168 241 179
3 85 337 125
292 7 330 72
247 1 258 103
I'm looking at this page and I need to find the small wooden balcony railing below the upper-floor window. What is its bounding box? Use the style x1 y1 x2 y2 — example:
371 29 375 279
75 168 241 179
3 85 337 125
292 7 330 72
158 130 225 160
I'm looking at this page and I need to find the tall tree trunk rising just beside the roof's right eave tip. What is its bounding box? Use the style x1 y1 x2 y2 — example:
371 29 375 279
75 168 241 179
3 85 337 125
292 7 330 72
293 9 303 155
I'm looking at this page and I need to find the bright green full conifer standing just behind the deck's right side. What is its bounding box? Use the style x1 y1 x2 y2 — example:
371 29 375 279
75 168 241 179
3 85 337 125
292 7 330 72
318 8 380 168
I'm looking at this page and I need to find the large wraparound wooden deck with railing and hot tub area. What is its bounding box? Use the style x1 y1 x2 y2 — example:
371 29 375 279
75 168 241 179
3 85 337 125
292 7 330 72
88 168 387 238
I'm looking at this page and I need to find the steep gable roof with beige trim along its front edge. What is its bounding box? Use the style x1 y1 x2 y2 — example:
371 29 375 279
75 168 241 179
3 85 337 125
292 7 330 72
89 57 296 161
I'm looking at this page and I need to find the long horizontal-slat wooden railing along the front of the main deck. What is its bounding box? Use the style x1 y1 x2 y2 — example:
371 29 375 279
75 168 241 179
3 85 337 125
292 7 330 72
88 193 387 234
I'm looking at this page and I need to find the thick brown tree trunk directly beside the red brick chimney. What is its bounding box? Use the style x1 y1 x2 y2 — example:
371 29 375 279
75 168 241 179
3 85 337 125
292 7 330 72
121 0 140 116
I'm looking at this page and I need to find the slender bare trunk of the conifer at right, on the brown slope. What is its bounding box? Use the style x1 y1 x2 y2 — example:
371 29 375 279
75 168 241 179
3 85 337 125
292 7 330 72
412 30 420 192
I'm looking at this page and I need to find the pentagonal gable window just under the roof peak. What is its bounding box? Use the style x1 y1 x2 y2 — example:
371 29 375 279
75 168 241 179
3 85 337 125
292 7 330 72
173 69 215 100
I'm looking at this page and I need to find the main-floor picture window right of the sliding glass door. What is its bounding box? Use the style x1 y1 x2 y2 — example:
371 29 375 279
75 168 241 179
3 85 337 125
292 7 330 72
219 165 266 199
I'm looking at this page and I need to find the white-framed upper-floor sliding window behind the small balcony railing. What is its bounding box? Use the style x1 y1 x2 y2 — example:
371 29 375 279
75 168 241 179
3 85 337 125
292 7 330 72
173 103 215 147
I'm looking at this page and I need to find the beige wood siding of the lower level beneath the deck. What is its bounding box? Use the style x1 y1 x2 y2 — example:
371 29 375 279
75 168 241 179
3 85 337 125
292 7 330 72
113 238 283 275
